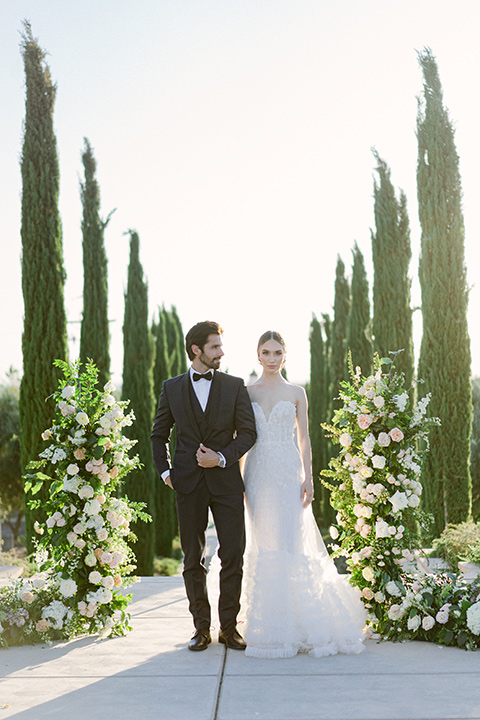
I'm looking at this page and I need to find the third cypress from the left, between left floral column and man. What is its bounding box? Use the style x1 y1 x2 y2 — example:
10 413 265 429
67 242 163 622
122 230 157 575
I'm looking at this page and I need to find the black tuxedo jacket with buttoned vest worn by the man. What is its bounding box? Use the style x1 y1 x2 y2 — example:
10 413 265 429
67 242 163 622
151 370 257 495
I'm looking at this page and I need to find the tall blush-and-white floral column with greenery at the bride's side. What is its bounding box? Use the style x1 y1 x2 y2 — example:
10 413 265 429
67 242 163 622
322 357 480 649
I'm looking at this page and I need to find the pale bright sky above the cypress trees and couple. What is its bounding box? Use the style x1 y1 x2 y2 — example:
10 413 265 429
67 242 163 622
0 0 480 382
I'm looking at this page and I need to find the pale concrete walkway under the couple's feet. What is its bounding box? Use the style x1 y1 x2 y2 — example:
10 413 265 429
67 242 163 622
0 577 480 720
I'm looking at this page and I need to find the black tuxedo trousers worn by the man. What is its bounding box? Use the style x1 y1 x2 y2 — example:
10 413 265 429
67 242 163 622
176 474 245 630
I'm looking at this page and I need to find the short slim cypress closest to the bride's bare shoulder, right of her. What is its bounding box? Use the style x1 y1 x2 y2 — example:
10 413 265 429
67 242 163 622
308 315 328 523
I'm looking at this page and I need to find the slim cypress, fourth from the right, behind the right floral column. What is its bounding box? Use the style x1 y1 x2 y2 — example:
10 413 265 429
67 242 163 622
330 256 350 409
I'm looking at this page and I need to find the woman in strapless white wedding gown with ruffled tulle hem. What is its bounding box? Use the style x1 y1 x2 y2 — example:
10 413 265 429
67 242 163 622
242 331 365 658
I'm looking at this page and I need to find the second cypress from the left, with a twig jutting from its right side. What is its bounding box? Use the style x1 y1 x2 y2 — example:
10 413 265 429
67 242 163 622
80 138 111 387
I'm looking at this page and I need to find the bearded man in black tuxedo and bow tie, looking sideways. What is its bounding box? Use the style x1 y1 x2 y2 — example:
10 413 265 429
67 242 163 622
152 322 256 650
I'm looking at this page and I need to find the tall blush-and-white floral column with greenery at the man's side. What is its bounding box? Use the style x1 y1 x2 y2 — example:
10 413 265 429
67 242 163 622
0 360 150 647
